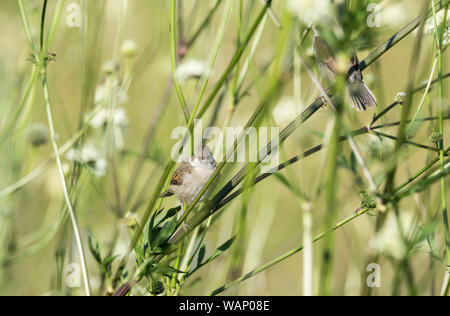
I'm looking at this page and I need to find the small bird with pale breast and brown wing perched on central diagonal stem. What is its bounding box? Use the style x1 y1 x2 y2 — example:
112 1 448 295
159 145 217 230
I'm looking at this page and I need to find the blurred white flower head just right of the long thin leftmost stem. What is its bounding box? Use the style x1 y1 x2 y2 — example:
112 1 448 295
66 143 107 178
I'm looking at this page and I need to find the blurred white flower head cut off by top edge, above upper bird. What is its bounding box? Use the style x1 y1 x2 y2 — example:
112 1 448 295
286 0 330 24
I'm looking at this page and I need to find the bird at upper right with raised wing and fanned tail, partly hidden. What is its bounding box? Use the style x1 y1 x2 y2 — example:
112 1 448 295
313 29 377 111
